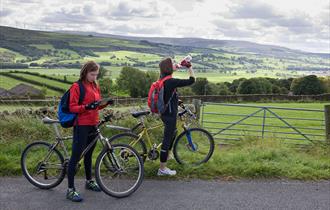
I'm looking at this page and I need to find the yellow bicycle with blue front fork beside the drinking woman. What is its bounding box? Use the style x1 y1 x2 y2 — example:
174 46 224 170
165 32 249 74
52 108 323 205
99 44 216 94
106 102 214 165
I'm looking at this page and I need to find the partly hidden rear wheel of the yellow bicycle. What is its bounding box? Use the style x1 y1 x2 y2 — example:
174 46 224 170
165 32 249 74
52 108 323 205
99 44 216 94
109 133 148 162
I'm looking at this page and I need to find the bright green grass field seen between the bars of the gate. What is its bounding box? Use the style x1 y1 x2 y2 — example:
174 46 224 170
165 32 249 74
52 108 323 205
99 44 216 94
202 103 329 144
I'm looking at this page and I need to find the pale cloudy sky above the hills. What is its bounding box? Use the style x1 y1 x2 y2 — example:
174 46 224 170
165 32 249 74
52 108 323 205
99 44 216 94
0 0 330 53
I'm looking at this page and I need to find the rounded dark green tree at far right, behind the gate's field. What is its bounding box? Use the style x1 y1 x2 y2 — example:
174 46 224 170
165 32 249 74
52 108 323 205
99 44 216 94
290 75 326 95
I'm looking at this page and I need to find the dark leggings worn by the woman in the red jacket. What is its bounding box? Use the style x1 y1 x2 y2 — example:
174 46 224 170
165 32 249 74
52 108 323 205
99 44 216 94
68 125 96 188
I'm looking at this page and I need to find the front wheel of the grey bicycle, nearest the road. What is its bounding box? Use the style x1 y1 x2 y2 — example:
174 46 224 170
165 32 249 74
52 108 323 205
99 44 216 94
95 144 144 198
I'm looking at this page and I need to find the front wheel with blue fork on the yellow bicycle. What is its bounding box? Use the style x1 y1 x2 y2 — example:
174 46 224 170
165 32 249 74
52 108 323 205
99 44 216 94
173 128 214 165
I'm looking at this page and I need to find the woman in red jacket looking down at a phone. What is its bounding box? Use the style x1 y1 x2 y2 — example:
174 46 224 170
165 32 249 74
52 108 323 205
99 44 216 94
66 61 111 202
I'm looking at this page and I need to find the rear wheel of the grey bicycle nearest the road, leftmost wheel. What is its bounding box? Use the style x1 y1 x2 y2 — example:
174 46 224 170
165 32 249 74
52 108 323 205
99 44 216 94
21 141 65 189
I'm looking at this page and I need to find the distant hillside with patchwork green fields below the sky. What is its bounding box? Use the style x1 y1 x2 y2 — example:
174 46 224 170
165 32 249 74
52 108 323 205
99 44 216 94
0 26 330 74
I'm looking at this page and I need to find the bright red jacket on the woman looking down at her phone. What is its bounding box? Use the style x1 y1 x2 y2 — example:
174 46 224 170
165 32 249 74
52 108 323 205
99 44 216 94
70 82 106 125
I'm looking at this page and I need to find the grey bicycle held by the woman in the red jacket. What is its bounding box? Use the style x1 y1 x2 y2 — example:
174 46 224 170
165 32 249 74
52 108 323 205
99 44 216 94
21 115 144 198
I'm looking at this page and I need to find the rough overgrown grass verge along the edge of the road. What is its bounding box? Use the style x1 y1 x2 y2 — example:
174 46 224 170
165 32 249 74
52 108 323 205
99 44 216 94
0 104 330 180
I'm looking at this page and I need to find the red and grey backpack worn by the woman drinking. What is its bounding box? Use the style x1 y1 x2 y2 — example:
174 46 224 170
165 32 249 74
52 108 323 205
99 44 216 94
148 75 174 114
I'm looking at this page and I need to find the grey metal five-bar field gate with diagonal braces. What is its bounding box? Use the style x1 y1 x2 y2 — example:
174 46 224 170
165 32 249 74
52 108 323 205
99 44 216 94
201 102 325 144
